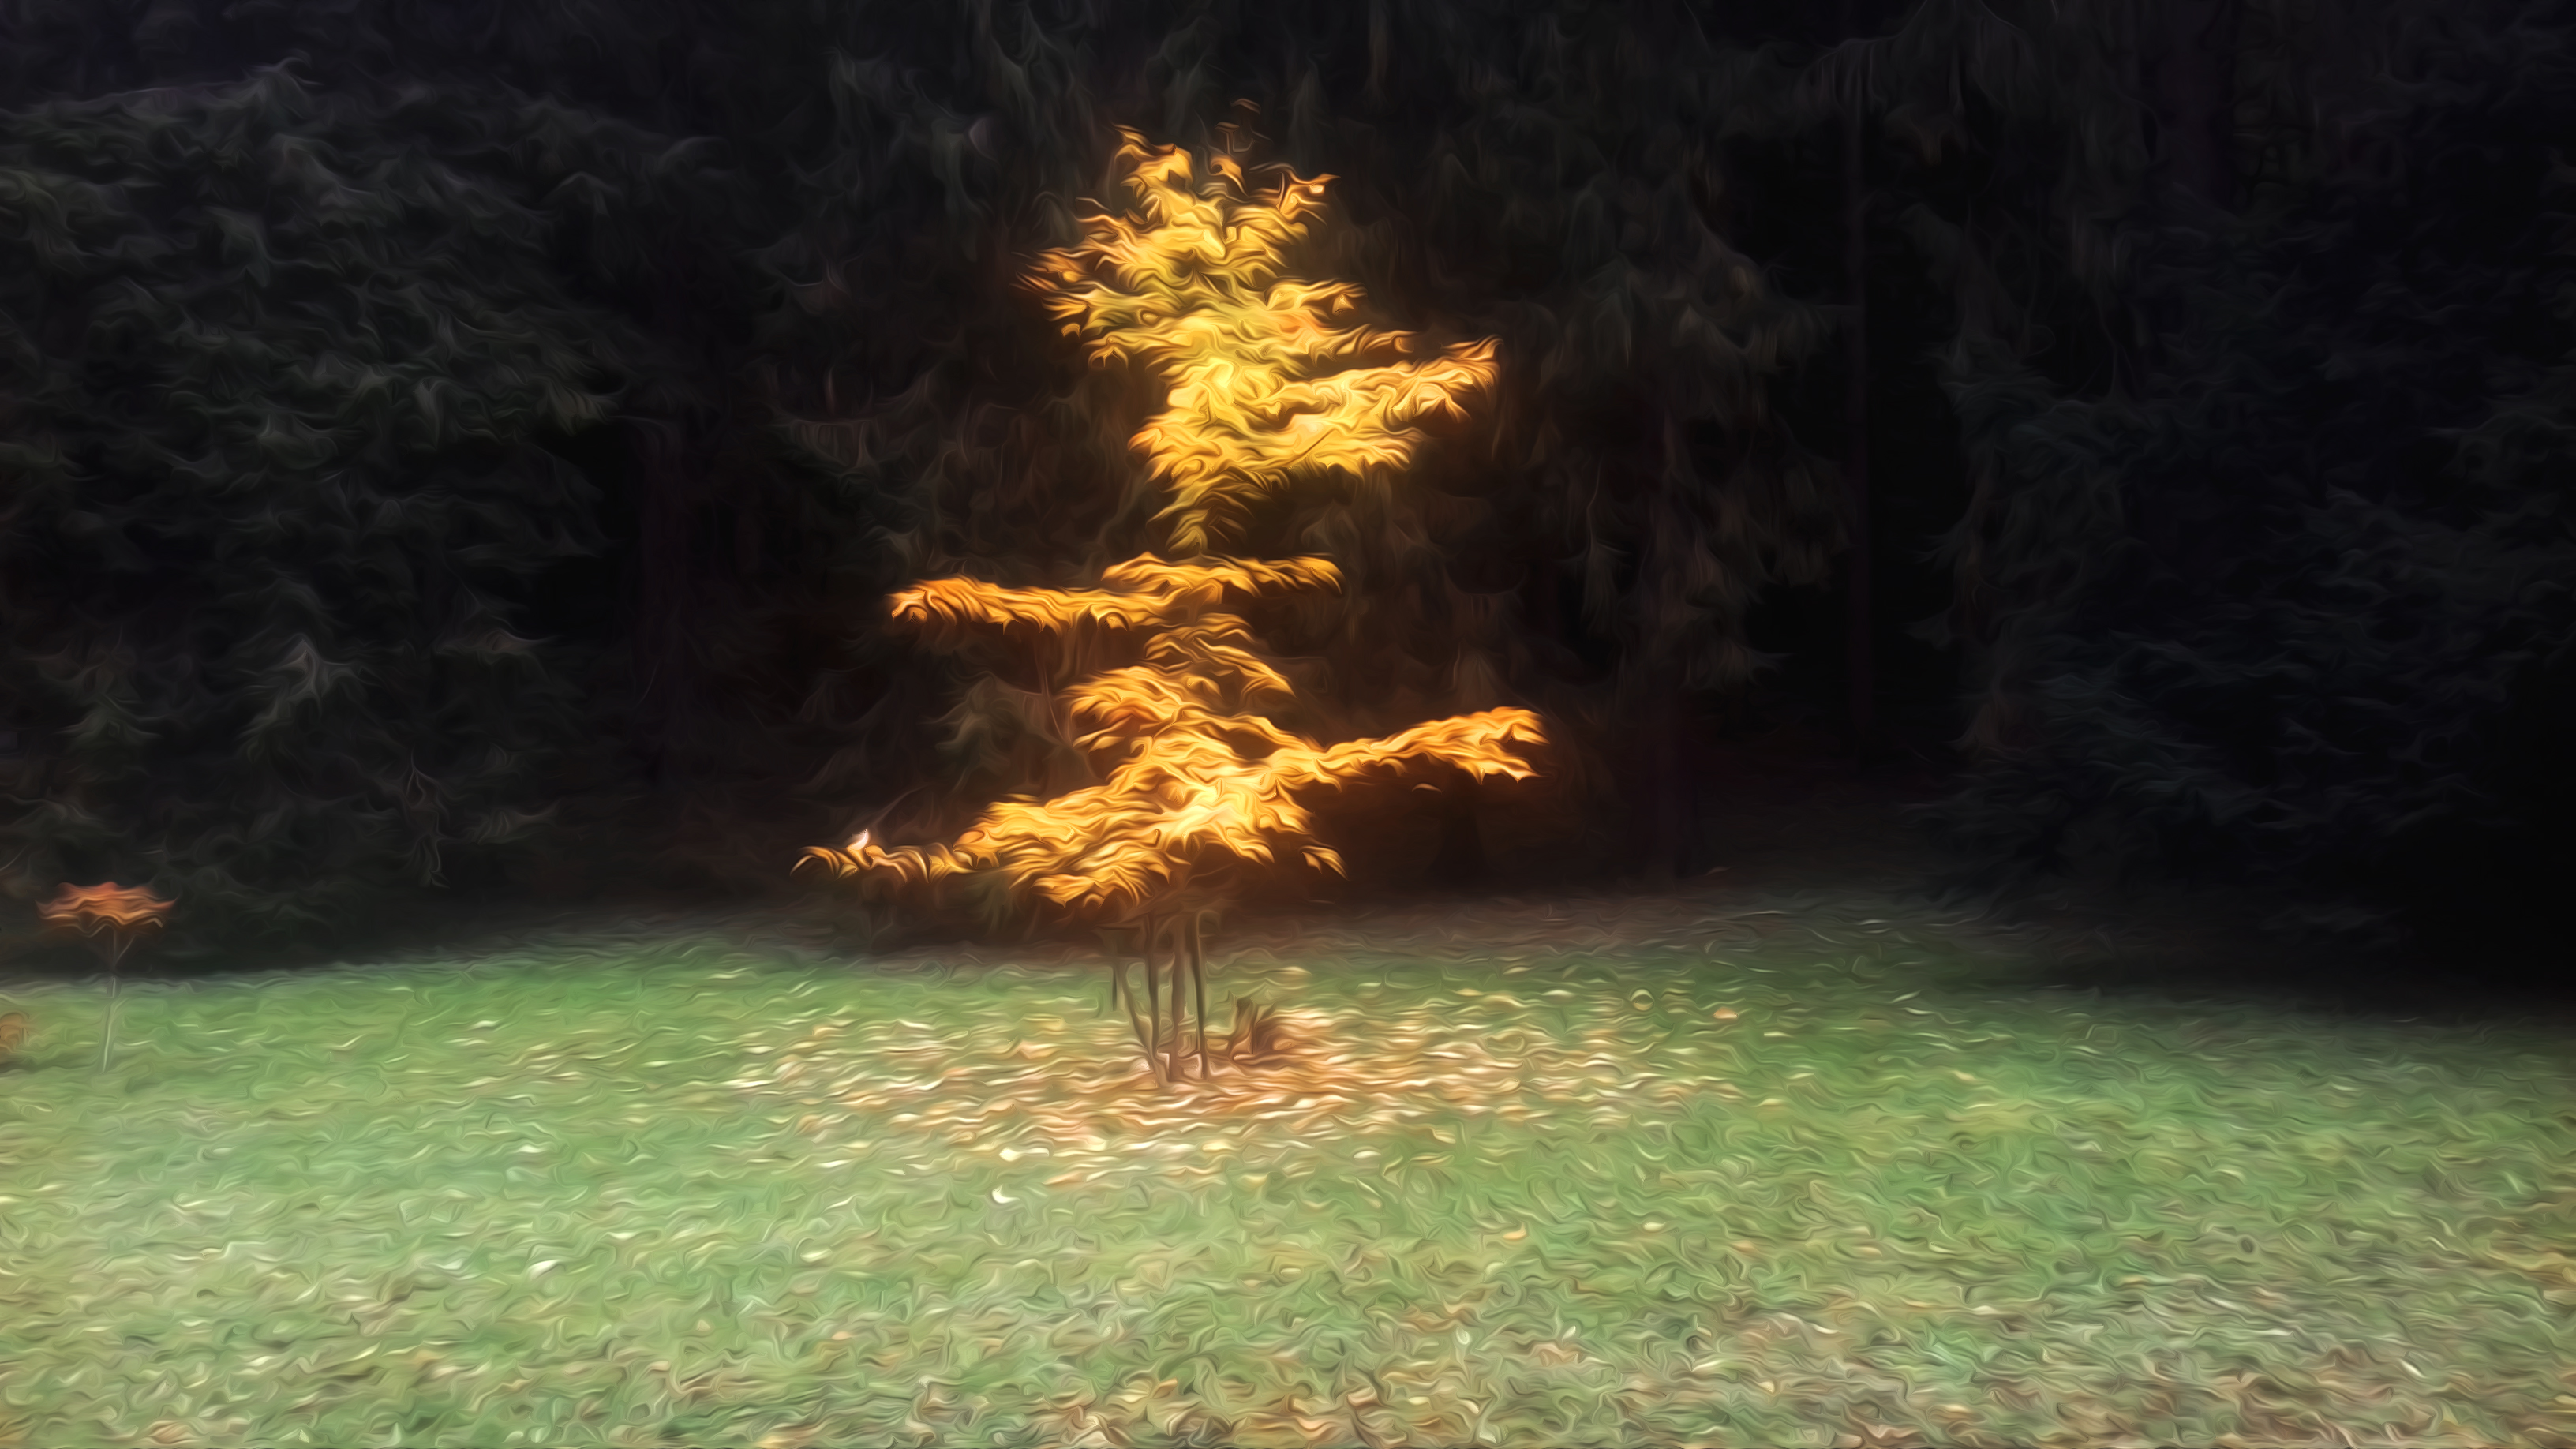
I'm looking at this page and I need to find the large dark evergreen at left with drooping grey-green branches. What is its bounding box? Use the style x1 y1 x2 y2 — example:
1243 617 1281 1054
0 69 716 928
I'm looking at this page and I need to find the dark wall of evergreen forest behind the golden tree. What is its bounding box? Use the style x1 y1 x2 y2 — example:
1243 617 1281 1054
0 0 2576 975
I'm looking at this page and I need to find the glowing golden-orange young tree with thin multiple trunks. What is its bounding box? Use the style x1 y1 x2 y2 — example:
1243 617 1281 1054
799 132 1543 1080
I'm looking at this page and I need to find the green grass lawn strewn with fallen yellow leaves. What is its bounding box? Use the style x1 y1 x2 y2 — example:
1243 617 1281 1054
0 897 2576 1449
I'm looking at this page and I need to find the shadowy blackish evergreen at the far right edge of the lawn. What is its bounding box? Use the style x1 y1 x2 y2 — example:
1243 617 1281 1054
1896 6 2576 938
